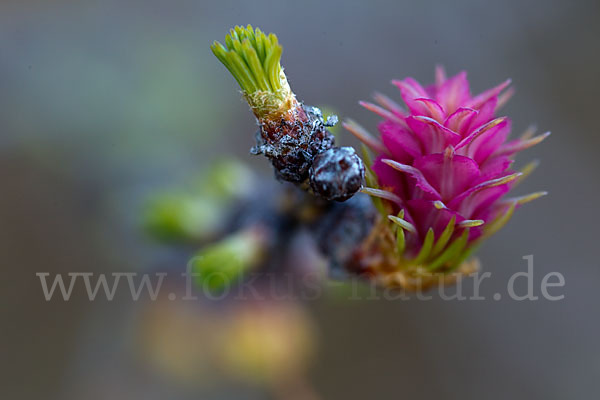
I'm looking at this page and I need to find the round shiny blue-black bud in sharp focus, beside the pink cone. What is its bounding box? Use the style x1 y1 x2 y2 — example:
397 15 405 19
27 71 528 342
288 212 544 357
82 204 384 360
309 147 365 201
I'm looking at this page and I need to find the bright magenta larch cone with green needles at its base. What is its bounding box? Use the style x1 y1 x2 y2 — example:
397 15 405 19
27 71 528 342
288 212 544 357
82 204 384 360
345 68 549 287
